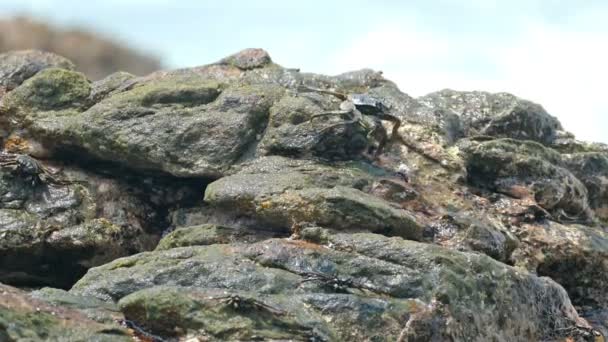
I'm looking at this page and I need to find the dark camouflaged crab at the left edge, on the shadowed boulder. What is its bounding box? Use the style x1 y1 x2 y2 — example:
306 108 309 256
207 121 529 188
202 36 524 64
0 152 68 186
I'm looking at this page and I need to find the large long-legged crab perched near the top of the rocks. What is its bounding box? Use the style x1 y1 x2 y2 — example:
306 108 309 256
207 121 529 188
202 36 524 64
298 85 401 158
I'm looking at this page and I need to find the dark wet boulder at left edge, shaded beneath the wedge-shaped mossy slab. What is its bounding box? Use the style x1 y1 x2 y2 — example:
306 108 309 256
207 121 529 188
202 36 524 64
0 156 157 286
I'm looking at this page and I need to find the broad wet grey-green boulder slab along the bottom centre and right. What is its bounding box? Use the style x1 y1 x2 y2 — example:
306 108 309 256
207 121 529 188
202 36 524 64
71 234 588 341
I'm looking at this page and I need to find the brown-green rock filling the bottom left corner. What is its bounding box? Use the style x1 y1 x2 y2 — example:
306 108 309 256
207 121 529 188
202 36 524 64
0 284 133 342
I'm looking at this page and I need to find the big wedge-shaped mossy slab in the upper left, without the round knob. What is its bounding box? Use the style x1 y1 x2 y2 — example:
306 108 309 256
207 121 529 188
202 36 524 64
65 77 281 177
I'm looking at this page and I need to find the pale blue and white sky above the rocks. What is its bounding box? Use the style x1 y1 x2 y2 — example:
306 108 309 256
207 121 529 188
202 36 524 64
0 0 608 143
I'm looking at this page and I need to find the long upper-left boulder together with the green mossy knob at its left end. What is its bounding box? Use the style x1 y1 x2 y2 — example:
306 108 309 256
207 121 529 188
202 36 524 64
0 69 282 177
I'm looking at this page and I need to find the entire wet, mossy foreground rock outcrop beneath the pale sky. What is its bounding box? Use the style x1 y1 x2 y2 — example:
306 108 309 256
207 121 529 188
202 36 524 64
0 49 608 341
